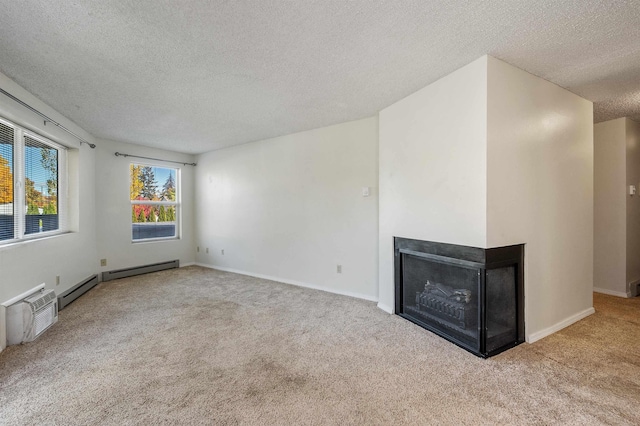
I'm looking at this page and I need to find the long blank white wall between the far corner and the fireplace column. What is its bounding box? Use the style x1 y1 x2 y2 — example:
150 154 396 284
196 117 378 300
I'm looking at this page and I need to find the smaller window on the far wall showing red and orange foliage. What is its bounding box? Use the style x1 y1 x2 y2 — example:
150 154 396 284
129 163 180 241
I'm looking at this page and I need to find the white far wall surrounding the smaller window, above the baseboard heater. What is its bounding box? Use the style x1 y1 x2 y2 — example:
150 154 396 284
92 139 199 271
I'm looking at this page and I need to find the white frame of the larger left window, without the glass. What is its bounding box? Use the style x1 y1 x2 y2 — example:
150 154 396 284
0 117 69 246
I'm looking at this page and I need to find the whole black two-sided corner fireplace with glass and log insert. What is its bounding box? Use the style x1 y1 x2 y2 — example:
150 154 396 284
394 237 524 358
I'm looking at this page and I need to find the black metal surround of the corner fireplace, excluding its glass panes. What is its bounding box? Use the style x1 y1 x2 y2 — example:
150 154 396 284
394 237 525 358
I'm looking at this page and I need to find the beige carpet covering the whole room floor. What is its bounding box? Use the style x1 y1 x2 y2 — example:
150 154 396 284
0 266 640 425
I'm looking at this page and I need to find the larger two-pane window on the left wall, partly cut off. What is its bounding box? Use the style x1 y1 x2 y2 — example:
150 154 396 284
0 116 66 244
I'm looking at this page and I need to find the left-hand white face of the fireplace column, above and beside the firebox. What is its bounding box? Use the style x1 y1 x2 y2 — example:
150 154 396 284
379 57 487 312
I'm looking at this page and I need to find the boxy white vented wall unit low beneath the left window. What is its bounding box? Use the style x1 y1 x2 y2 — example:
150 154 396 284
7 289 58 345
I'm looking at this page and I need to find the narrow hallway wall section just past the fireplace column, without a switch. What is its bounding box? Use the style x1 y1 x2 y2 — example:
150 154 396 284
593 118 628 295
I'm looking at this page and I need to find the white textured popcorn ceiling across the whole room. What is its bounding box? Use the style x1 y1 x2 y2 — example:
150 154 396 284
0 0 640 153
